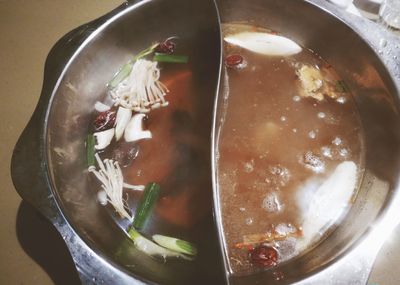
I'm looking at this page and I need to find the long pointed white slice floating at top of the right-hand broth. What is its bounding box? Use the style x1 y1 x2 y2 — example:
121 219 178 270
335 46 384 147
224 32 302 56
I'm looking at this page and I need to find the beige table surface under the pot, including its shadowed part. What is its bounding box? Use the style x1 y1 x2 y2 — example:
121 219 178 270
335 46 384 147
0 0 400 285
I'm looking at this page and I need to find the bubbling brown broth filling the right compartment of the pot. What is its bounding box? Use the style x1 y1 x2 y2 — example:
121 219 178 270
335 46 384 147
216 24 363 275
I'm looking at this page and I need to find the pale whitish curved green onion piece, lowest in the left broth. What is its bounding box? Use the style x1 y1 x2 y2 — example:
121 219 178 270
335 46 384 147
128 227 193 260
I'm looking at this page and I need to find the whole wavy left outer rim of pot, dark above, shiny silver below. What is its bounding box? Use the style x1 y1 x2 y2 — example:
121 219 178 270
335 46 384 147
11 1 142 284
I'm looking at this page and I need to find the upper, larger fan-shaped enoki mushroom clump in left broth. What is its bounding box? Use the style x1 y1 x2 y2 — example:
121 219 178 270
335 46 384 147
110 59 169 113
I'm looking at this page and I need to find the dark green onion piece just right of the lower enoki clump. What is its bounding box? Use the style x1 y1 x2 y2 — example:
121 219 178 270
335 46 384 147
133 182 160 229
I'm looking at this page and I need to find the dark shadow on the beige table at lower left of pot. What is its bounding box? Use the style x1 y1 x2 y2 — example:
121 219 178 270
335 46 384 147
16 201 80 285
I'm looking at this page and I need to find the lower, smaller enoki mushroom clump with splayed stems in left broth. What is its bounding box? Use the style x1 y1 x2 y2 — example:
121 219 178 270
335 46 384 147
89 153 144 220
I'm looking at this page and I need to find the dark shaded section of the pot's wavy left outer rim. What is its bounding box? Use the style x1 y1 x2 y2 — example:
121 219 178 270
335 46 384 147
11 0 128 229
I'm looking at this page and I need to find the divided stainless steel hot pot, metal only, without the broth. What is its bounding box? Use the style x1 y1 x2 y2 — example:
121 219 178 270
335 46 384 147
12 0 400 284
